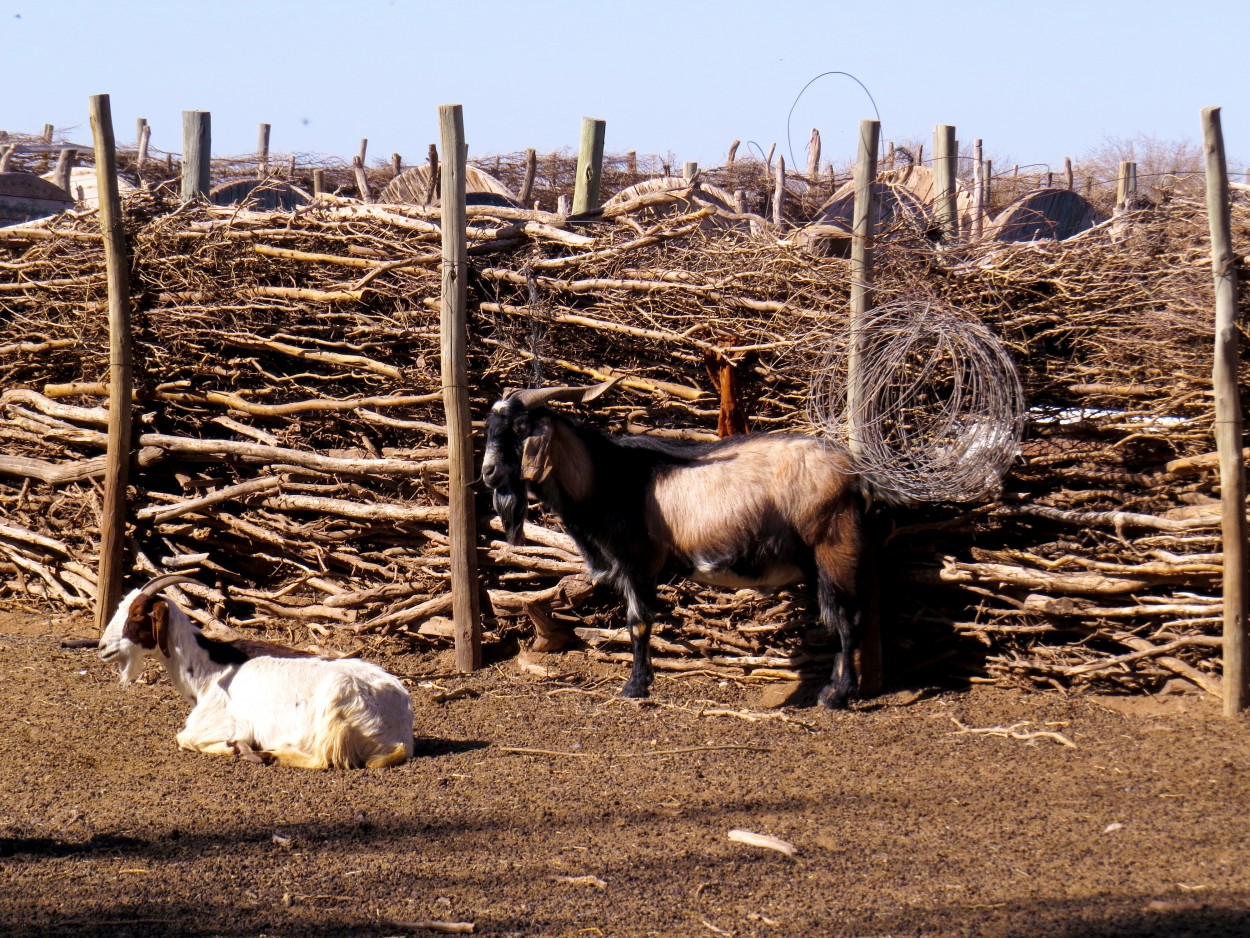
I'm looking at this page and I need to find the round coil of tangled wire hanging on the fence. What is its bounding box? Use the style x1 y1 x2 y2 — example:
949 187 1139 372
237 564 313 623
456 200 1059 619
808 300 1025 503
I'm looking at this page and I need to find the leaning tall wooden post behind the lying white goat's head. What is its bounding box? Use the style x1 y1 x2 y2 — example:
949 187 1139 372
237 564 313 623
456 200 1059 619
91 95 134 633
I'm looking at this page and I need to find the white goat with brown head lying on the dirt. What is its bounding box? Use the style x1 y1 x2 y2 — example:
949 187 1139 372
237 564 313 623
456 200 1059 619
100 574 413 769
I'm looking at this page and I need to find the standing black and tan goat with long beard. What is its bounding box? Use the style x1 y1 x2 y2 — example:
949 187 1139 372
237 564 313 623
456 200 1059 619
481 381 865 708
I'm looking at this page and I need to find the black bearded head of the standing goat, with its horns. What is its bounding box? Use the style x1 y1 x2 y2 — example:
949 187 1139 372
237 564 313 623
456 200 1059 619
481 378 620 544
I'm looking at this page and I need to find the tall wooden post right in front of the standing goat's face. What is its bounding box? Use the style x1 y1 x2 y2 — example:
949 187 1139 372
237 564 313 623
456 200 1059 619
439 104 481 672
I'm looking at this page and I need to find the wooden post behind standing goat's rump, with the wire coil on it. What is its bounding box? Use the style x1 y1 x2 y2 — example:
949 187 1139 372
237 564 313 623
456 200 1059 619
846 120 881 697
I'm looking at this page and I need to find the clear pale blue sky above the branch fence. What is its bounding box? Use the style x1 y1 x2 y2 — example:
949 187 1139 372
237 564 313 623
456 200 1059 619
0 0 1250 170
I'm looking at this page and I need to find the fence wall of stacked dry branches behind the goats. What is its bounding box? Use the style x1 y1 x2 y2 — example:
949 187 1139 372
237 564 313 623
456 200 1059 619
0 177 1250 688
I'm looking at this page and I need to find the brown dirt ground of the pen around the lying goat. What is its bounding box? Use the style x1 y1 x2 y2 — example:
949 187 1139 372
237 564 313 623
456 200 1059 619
0 613 1250 938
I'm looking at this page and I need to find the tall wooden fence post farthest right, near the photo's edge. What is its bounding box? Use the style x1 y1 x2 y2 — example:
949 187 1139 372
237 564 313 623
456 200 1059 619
1203 108 1250 717
